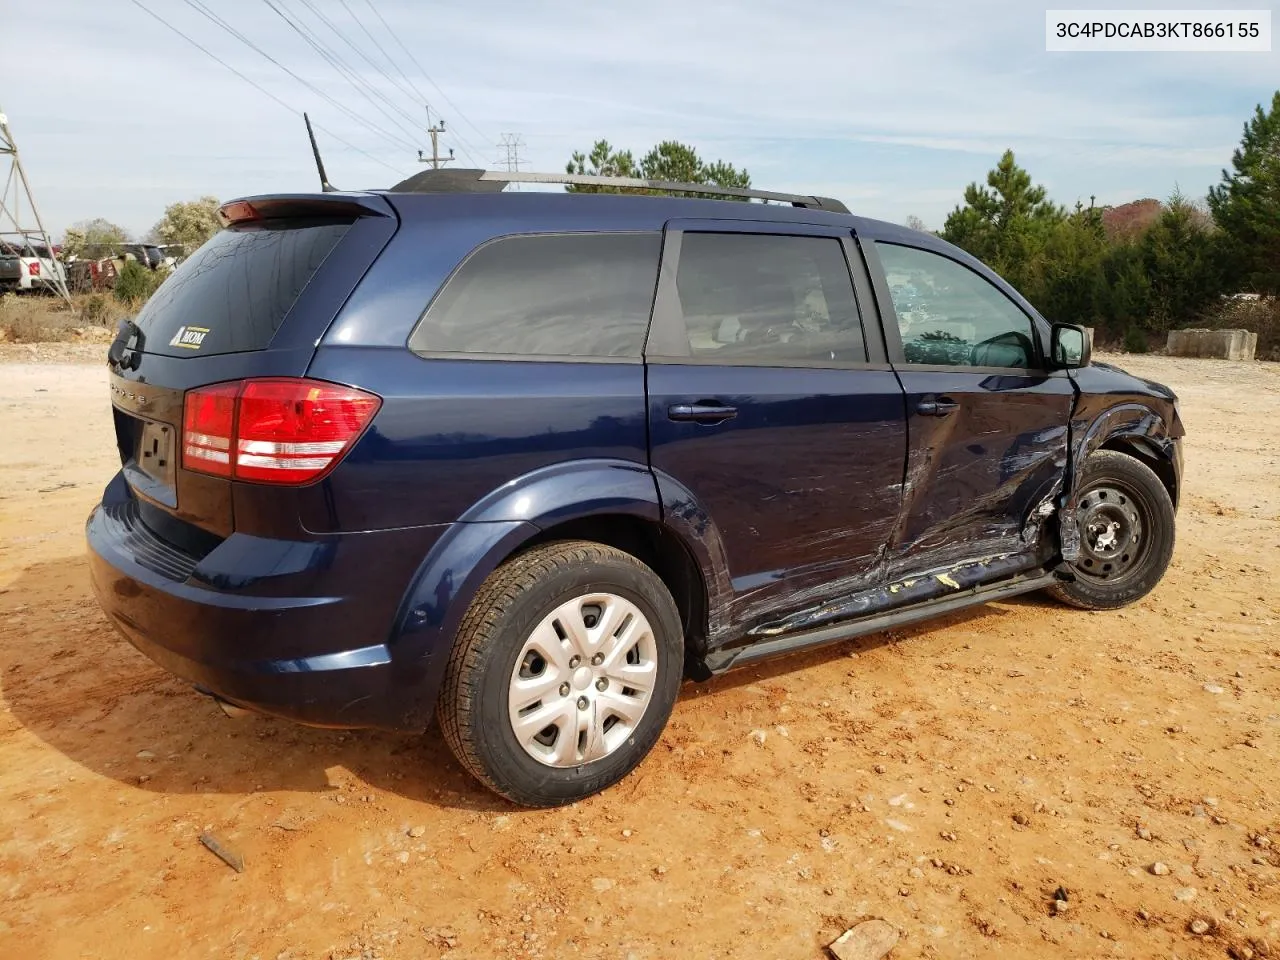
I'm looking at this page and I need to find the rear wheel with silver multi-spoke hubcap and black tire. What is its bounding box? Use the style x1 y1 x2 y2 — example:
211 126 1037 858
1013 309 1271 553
436 540 685 806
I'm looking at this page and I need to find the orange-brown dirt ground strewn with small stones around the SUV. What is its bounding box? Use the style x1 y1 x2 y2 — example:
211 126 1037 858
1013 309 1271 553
0 346 1280 960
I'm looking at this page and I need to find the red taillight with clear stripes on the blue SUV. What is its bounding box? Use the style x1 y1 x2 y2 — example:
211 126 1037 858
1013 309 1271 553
182 378 383 484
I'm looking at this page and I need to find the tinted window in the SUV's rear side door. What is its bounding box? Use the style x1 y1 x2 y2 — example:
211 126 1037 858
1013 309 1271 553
676 233 867 365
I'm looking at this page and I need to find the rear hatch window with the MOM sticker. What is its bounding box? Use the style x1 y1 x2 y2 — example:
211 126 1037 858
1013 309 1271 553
136 219 351 357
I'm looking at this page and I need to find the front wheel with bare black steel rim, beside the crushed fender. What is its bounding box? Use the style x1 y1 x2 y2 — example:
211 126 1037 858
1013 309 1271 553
1050 451 1174 611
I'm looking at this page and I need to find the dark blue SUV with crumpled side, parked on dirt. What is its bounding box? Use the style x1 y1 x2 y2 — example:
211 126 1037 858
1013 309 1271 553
87 170 1183 805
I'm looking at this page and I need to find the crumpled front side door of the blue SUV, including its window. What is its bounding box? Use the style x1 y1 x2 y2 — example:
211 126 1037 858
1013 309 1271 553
863 239 1074 570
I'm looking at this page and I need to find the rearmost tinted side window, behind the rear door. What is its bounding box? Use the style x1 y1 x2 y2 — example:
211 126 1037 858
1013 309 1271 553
410 233 662 357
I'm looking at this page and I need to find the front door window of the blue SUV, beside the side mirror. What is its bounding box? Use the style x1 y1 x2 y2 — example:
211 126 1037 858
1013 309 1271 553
876 242 1037 369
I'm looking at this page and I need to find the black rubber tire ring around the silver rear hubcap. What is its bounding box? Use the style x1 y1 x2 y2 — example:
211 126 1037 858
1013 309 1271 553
463 558 684 805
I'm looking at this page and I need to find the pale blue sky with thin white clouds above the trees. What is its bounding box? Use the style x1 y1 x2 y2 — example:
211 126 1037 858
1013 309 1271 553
0 0 1280 237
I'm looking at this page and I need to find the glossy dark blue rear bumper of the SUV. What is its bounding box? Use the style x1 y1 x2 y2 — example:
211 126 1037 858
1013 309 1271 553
86 477 444 730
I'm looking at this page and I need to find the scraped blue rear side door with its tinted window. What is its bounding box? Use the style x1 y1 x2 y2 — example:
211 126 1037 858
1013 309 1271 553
646 220 906 634
